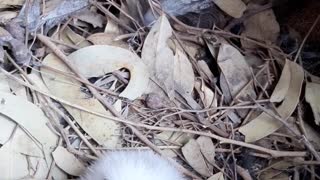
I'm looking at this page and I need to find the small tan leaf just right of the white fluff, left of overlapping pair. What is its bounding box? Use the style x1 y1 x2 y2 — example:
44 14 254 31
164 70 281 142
181 139 212 177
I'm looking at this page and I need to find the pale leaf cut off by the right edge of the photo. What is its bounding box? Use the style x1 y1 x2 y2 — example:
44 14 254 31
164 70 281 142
305 82 320 125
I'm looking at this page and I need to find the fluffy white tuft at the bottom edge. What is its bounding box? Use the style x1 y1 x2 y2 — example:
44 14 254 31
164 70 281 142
80 151 184 180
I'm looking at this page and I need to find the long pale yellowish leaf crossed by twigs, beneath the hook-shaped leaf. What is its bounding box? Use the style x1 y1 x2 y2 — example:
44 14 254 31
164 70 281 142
41 54 119 147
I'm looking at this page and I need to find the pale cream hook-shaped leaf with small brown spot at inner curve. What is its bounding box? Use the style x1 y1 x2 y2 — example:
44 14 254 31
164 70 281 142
69 45 149 100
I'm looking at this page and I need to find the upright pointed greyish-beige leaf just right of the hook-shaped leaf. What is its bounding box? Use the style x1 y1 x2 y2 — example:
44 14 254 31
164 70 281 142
141 15 174 99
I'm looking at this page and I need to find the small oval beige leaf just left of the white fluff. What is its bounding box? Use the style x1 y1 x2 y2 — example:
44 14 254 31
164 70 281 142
52 146 85 176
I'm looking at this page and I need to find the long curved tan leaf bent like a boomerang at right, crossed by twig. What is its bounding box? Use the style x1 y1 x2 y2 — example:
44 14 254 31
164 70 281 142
239 60 304 142
